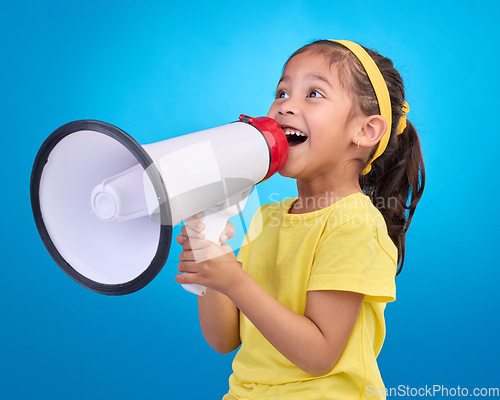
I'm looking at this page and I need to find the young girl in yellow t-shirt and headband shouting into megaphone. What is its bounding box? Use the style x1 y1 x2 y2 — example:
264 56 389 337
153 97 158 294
176 40 425 400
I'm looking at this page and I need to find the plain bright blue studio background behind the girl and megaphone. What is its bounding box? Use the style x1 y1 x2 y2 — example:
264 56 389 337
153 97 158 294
0 0 500 400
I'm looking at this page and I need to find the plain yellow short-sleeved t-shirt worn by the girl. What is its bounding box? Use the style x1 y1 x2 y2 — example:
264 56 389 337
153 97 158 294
223 193 397 400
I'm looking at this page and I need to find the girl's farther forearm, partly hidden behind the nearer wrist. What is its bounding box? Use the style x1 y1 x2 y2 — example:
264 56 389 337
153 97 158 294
198 289 240 354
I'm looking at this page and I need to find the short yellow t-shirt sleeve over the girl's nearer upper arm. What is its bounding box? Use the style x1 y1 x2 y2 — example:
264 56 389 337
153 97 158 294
308 220 397 302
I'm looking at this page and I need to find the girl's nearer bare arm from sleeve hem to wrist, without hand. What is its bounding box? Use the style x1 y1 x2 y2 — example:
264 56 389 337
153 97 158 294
227 275 364 376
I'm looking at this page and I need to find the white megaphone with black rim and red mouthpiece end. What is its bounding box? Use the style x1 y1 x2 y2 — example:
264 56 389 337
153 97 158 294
31 115 288 295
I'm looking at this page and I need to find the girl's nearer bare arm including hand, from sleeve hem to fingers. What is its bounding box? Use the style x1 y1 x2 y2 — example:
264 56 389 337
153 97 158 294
176 230 364 375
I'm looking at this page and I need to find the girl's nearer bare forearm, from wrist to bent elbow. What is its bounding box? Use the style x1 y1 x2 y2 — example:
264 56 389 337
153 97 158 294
227 271 343 375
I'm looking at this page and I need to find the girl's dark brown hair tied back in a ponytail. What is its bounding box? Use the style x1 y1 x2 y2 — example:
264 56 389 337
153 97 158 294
285 40 425 274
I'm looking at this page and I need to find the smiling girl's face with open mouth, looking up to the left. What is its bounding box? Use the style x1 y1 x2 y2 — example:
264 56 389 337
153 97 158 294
268 50 359 180
